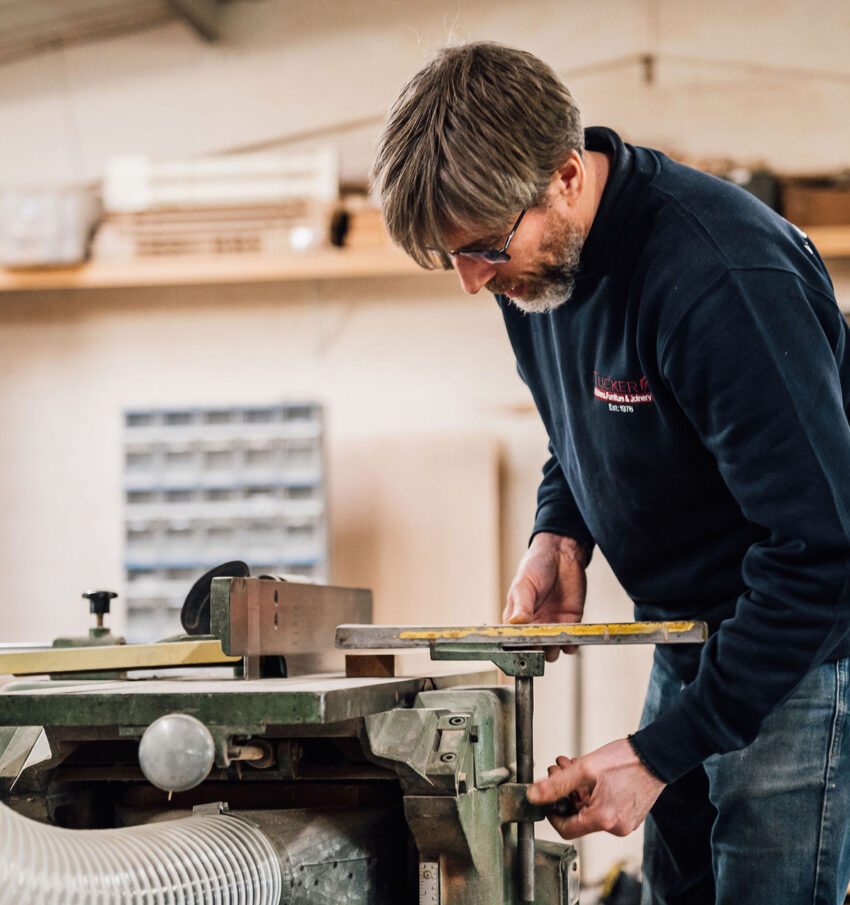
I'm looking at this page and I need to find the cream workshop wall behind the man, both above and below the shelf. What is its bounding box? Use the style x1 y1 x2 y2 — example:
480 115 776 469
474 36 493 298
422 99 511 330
0 0 850 879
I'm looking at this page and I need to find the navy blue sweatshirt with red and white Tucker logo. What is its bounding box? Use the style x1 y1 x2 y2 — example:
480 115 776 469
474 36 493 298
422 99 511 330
497 128 850 782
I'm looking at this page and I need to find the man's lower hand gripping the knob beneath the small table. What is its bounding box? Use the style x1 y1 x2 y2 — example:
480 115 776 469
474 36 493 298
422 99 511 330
528 739 664 839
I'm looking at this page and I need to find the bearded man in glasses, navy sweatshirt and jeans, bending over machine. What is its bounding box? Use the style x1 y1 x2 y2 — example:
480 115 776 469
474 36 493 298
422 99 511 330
373 44 850 905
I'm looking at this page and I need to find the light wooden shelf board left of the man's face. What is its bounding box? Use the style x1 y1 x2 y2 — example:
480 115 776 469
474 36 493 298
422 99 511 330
0 247 425 292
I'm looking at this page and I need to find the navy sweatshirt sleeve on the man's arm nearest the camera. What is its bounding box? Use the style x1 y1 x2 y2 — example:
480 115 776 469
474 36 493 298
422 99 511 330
632 270 850 782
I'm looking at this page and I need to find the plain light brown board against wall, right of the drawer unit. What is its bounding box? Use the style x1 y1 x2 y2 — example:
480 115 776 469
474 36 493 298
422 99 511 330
328 434 501 624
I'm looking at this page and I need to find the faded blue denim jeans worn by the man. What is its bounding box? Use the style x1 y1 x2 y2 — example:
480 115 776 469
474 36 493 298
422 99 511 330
641 658 850 905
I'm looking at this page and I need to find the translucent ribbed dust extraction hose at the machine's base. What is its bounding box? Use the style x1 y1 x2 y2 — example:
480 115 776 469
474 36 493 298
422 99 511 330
0 805 281 905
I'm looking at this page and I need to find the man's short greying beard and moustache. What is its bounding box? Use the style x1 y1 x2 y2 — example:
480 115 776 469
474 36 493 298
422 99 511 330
487 225 584 314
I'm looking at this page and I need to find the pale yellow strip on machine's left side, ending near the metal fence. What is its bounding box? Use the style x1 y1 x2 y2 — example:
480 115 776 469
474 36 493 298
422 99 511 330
0 641 242 676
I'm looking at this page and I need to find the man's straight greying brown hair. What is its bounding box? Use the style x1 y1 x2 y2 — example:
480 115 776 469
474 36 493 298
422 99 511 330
370 42 584 269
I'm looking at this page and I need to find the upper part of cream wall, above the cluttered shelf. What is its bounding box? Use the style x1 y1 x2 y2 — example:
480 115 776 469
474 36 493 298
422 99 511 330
0 0 850 184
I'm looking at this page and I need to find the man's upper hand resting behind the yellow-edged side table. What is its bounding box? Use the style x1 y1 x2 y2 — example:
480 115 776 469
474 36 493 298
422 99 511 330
502 532 587 660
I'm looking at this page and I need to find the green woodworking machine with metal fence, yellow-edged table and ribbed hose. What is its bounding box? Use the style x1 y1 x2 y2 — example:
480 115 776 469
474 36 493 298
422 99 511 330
0 571 705 905
